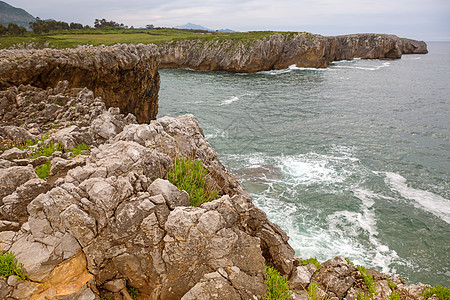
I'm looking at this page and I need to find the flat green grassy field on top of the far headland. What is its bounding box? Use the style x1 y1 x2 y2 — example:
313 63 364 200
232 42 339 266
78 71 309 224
0 29 302 49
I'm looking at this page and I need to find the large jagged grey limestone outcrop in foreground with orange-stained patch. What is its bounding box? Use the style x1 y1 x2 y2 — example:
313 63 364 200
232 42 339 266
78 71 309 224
0 83 294 299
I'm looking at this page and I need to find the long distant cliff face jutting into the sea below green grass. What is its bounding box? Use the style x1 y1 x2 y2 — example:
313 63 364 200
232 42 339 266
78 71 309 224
158 33 427 73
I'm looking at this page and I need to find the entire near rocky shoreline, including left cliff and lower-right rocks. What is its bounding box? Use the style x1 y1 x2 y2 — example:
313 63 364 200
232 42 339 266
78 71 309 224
0 40 438 300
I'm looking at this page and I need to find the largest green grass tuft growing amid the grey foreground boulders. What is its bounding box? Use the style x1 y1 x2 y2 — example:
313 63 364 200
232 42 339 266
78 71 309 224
167 158 219 206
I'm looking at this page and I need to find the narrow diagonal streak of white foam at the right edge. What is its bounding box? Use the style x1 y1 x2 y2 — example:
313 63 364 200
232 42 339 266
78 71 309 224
385 172 450 224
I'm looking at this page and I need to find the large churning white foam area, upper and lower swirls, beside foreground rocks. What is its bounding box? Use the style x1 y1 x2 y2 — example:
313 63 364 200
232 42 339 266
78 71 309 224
227 151 411 274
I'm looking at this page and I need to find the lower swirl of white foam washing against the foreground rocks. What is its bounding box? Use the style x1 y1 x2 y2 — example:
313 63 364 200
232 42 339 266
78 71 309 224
252 188 404 274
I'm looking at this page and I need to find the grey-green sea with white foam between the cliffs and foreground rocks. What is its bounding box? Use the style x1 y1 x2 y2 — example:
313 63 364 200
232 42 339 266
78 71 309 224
158 42 450 286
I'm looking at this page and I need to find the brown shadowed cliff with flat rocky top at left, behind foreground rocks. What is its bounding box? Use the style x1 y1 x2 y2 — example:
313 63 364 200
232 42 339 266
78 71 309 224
0 45 159 123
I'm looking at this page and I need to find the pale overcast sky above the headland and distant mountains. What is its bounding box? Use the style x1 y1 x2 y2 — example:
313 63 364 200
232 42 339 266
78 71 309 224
4 0 450 41
